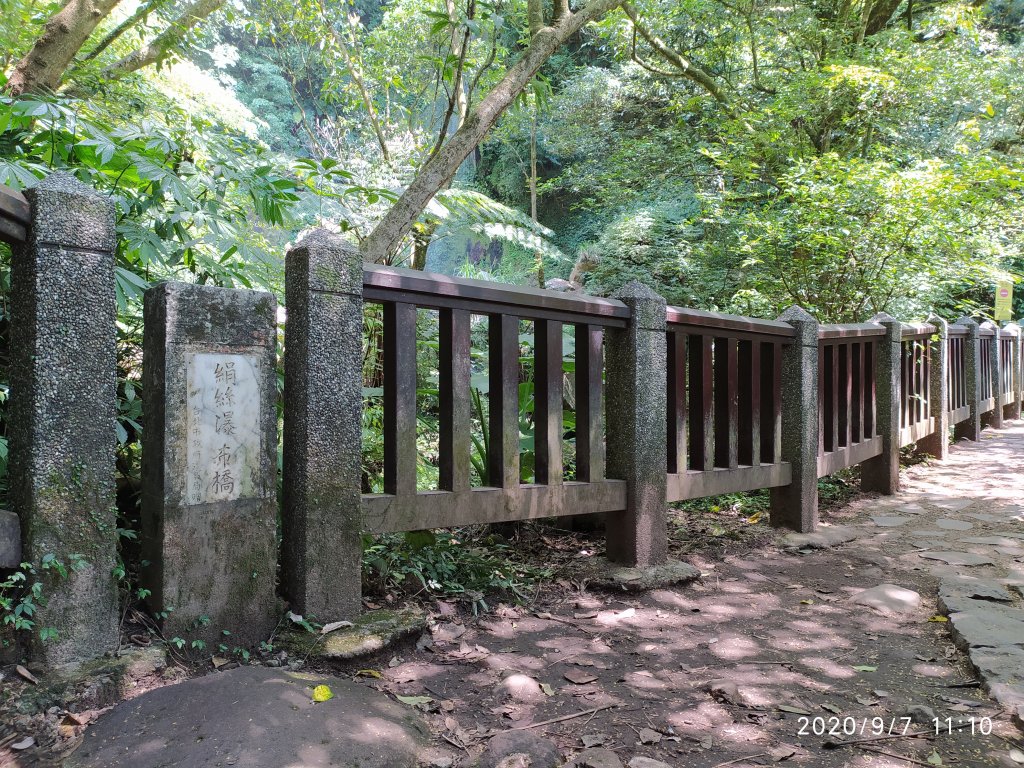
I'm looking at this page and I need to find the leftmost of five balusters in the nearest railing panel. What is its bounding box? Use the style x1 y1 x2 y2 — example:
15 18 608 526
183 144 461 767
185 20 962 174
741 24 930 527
384 302 417 496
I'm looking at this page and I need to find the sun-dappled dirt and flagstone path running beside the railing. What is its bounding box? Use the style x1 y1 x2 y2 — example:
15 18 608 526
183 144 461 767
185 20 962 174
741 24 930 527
46 422 1024 768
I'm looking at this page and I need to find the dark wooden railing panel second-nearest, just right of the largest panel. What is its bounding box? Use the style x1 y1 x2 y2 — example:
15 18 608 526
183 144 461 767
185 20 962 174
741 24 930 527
667 306 794 502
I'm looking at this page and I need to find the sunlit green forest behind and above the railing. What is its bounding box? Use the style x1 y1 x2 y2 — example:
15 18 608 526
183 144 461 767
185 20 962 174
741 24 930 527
0 0 1024 638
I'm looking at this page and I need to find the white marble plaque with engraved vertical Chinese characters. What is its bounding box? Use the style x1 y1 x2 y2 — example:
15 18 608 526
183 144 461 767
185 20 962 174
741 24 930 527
184 352 262 505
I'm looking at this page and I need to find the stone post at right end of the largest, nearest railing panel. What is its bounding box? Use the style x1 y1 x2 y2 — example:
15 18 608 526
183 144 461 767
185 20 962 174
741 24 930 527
606 281 669 567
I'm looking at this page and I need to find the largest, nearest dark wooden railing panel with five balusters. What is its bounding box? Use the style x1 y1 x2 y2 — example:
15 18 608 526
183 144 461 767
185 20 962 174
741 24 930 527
362 266 630 532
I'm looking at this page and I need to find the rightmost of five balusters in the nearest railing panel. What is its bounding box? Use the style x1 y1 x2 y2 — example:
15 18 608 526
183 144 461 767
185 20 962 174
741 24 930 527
575 325 604 482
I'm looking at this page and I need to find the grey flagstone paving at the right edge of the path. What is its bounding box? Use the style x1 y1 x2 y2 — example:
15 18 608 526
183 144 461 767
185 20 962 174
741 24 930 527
831 422 1024 723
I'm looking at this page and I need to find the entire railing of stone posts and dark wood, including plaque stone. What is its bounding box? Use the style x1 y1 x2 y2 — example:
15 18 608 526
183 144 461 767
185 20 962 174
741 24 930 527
0 175 1022 660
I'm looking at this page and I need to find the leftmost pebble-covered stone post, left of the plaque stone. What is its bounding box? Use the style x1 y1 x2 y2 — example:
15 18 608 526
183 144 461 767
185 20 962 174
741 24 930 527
9 173 118 664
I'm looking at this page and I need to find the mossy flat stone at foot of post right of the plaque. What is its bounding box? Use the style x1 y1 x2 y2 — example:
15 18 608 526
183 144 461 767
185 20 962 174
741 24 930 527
282 608 427 660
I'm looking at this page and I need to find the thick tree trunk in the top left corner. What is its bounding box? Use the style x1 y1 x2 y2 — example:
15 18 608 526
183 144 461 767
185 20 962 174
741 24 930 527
7 0 120 96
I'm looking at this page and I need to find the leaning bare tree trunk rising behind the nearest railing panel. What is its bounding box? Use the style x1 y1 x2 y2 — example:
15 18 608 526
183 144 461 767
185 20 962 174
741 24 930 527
362 0 621 262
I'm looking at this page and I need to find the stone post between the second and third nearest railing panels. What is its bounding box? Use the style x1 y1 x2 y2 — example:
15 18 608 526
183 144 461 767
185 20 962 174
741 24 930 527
771 306 819 532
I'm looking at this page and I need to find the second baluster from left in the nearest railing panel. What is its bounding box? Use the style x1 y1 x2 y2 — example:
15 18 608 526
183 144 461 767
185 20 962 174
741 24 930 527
438 309 472 492
